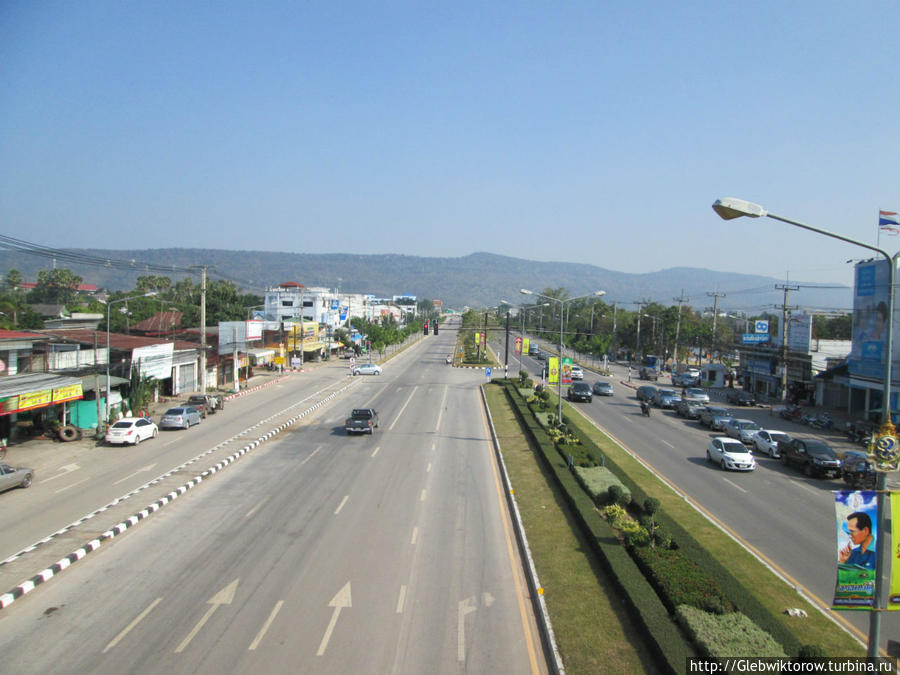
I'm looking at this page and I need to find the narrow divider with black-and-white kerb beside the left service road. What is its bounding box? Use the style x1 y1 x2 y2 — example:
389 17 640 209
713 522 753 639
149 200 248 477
0 380 356 609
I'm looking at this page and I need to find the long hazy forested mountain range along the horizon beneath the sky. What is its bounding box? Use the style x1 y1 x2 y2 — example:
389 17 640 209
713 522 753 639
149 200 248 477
0 248 852 312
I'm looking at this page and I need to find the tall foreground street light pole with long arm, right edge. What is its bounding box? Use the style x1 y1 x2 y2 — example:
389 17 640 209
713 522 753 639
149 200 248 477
712 197 900 657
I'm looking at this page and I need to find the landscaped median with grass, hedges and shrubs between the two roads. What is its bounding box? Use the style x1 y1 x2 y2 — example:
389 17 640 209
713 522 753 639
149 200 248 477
486 385 864 673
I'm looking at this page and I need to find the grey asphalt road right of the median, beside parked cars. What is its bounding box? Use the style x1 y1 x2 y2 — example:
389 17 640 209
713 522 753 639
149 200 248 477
499 338 900 648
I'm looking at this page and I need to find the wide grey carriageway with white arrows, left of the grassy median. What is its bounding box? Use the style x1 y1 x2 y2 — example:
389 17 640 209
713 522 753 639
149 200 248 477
0 330 546 673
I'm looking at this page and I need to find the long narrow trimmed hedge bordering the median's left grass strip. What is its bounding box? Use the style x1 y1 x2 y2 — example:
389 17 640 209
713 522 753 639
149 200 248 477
505 387 697 673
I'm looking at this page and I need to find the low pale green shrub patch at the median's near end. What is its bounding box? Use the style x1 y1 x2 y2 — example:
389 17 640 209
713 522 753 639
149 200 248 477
675 605 787 658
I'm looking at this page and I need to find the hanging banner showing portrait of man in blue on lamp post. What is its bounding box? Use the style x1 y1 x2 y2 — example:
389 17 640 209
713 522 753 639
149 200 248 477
832 490 878 610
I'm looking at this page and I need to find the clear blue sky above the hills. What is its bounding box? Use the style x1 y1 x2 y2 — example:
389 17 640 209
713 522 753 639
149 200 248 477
0 0 900 284
